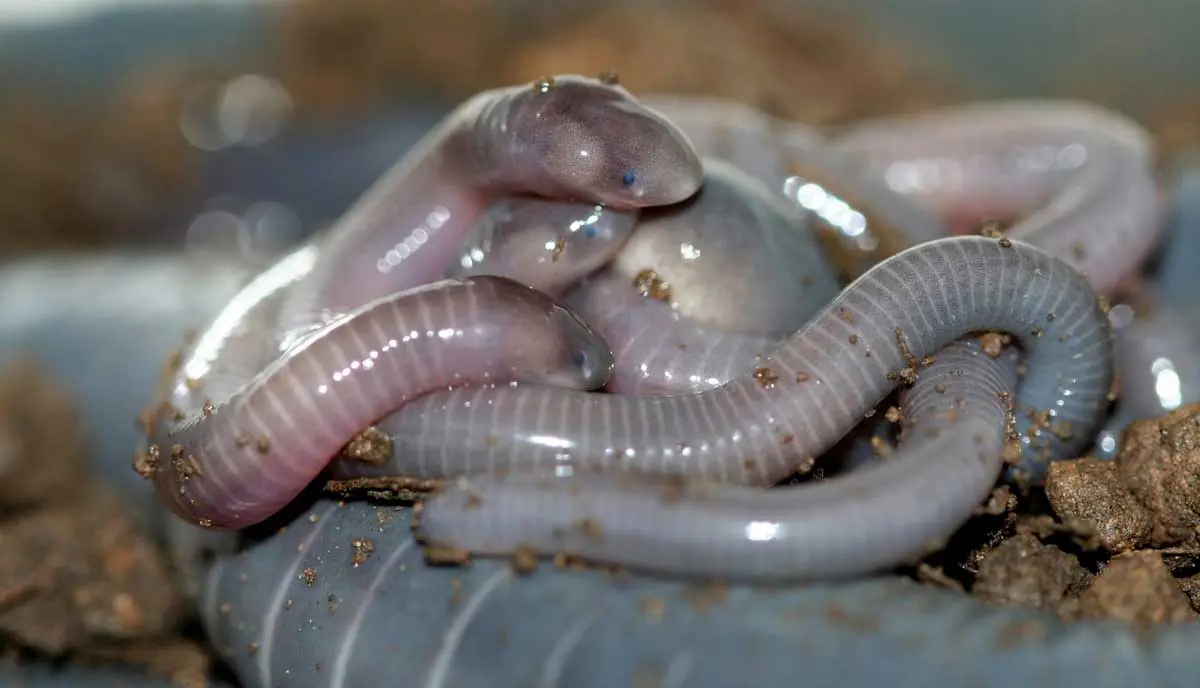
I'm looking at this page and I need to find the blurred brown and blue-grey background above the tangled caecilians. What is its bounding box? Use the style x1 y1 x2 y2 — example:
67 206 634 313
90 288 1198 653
0 0 1200 259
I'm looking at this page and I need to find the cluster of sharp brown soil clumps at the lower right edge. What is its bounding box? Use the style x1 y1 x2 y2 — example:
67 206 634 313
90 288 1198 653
943 405 1200 627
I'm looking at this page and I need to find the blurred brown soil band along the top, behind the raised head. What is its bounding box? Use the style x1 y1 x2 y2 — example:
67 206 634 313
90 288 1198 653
280 0 964 124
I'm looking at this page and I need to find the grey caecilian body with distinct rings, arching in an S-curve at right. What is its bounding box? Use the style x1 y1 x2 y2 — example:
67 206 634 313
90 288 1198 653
338 237 1112 494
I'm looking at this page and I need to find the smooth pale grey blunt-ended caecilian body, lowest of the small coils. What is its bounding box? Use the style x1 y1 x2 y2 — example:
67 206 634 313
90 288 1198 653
416 342 1016 581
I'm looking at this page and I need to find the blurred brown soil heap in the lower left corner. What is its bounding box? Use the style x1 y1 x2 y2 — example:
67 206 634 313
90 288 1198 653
0 359 210 686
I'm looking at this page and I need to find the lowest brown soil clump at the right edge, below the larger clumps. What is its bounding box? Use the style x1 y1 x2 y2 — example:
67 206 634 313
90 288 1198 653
1079 551 1196 626
